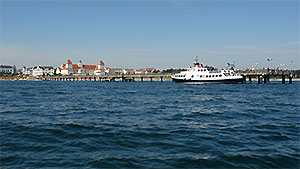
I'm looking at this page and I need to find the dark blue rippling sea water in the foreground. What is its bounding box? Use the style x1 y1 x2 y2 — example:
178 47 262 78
0 81 300 168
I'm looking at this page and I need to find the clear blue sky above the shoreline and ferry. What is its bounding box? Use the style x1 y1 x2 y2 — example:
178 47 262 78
0 0 300 70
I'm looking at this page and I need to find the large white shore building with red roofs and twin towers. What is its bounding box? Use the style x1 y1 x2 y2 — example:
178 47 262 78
56 59 105 75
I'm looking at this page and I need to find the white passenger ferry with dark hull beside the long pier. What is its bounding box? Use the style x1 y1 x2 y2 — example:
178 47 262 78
171 57 243 83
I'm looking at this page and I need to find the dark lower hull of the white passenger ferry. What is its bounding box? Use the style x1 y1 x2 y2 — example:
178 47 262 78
173 78 243 84
